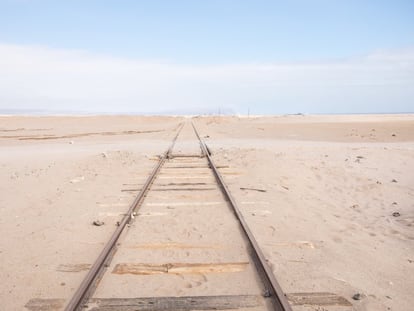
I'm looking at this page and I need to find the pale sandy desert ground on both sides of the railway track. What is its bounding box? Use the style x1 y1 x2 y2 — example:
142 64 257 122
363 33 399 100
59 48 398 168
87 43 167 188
0 115 414 310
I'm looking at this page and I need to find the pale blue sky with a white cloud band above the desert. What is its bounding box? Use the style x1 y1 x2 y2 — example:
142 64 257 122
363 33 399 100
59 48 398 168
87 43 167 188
0 0 414 114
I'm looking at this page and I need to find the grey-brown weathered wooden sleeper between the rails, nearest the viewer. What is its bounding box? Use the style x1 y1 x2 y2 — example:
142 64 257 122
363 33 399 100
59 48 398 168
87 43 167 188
87 295 263 311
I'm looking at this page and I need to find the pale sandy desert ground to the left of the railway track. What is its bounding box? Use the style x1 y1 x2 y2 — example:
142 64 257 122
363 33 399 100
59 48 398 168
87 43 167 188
0 117 179 310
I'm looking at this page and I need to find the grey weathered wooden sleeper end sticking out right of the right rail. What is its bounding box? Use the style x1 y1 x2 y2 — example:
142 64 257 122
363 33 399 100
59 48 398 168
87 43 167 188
287 292 352 307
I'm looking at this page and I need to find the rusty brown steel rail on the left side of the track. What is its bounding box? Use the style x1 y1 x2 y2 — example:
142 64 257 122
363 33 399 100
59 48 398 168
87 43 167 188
65 123 183 311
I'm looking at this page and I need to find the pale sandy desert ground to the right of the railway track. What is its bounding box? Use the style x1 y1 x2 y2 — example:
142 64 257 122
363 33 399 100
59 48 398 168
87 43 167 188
197 115 414 310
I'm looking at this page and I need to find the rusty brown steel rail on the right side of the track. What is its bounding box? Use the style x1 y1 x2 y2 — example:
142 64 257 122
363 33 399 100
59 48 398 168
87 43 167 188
191 123 292 311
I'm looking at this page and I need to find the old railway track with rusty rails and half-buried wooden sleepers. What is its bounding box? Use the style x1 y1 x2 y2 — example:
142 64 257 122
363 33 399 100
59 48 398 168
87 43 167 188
65 122 291 311
